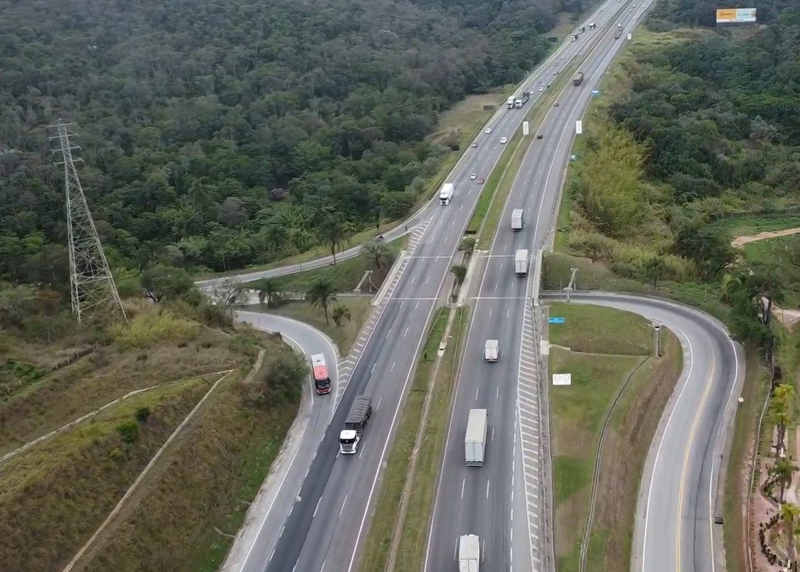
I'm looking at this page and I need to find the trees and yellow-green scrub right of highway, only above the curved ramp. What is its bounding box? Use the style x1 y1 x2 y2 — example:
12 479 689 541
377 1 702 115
568 0 800 335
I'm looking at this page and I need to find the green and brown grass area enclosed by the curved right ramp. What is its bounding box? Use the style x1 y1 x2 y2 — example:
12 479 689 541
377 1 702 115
550 304 681 572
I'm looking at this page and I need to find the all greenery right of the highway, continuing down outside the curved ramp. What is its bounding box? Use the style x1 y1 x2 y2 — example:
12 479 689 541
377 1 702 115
543 0 800 570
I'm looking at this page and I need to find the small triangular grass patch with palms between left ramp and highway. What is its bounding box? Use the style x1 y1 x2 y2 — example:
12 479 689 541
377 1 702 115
260 296 372 356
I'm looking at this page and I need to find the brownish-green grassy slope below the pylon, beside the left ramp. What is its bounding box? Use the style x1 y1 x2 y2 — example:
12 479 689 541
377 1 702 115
0 285 307 572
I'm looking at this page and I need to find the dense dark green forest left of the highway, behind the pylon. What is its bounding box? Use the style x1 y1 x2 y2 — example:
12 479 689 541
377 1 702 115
0 0 583 283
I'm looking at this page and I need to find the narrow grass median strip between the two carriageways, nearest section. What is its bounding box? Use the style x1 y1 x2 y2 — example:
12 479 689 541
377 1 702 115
359 308 468 572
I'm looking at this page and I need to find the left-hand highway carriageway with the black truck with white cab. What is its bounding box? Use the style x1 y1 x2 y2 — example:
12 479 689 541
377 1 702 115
253 13 620 572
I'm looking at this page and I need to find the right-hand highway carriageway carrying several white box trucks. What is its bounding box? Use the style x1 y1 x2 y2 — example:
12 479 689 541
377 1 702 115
425 3 646 572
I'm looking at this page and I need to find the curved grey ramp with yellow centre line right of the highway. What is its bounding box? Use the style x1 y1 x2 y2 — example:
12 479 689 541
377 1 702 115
544 292 744 572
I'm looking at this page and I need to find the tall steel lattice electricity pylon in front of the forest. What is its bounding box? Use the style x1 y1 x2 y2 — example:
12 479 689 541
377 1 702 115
48 119 127 323
